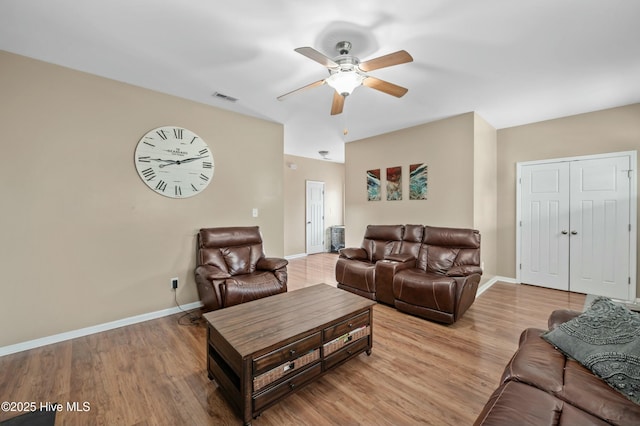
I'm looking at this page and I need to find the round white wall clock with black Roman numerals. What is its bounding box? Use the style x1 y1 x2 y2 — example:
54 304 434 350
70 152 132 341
135 126 214 198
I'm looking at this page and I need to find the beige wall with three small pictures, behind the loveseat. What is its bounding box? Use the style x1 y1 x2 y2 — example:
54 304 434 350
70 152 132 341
345 113 496 281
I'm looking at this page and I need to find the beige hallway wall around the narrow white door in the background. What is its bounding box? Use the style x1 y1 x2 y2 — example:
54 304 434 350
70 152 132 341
284 155 344 256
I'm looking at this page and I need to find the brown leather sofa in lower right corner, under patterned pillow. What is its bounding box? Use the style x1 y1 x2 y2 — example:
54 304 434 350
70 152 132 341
474 310 640 426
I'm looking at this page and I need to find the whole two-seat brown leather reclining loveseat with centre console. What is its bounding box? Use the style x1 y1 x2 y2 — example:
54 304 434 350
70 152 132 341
336 225 482 324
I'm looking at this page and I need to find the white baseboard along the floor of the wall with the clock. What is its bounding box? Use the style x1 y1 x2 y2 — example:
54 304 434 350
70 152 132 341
0 301 202 357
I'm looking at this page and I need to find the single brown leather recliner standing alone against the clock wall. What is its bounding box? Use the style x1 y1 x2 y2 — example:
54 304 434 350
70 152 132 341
195 226 289 312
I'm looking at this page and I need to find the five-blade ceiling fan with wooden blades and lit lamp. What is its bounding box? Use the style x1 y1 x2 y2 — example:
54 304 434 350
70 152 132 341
278 41 413 115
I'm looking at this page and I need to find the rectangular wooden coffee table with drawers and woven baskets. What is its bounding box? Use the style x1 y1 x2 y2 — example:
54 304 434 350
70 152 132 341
204 284 375 425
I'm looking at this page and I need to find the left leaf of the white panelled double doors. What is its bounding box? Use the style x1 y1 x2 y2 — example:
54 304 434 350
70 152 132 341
520 163 569 290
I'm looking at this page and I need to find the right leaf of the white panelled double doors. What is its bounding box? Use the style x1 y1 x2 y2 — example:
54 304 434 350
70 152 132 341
569 157 631 300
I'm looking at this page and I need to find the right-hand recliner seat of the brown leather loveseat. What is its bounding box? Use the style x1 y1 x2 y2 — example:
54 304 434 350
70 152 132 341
393 226 482 324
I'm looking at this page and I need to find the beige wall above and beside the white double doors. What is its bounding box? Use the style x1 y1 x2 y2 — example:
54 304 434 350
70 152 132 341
497 104 640 294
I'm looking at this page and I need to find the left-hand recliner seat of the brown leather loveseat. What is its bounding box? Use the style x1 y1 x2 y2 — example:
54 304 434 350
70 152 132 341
336 225 404 300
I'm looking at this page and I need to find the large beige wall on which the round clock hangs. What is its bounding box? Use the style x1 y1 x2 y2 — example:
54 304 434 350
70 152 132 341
0 52 284 347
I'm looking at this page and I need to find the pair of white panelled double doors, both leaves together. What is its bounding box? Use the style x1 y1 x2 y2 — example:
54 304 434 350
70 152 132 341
518 153 636 300
